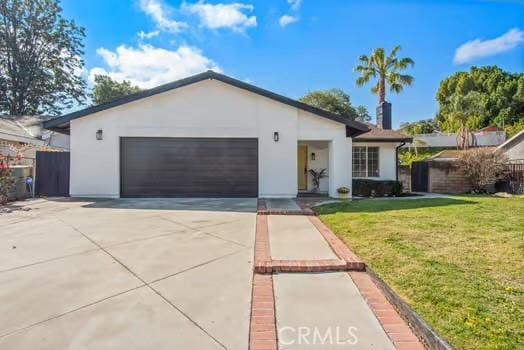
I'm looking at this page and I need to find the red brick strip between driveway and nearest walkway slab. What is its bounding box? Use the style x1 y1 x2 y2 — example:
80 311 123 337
249 273 278 350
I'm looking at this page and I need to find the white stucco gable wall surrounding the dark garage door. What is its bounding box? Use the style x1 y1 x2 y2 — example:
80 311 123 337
71 80 351 197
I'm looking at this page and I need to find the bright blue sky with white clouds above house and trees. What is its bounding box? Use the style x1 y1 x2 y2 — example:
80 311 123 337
61 0 524 127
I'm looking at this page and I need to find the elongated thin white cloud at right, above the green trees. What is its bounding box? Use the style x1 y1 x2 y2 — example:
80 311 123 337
453 28 524 64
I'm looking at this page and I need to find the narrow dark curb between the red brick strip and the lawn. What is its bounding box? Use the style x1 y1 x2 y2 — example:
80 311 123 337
366 268 453 350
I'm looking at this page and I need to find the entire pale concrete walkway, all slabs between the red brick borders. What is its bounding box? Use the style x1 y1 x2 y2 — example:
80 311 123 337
268 206 395 350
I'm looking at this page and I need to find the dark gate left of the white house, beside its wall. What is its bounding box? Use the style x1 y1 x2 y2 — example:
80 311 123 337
35 151 70 197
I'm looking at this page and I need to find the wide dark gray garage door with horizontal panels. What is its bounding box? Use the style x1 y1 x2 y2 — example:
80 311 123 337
120 137 258 197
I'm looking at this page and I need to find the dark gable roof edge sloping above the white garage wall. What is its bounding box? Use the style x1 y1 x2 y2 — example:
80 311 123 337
44 71 369 135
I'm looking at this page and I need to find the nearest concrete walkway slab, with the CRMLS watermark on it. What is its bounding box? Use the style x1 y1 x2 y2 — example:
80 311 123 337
274 272 394 350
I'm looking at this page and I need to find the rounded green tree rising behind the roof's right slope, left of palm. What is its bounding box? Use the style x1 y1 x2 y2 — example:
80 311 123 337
300 89 371 121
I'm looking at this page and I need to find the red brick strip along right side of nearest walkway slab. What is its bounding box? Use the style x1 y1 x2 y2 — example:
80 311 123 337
348 271 425 350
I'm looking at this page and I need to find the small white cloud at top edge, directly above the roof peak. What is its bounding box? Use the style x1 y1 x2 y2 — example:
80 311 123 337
182 1 257 32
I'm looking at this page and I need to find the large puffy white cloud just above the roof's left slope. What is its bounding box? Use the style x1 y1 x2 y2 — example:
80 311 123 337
89 44 221 89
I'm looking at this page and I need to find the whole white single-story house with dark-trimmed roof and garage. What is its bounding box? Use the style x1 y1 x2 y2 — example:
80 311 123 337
44 71 410 197
